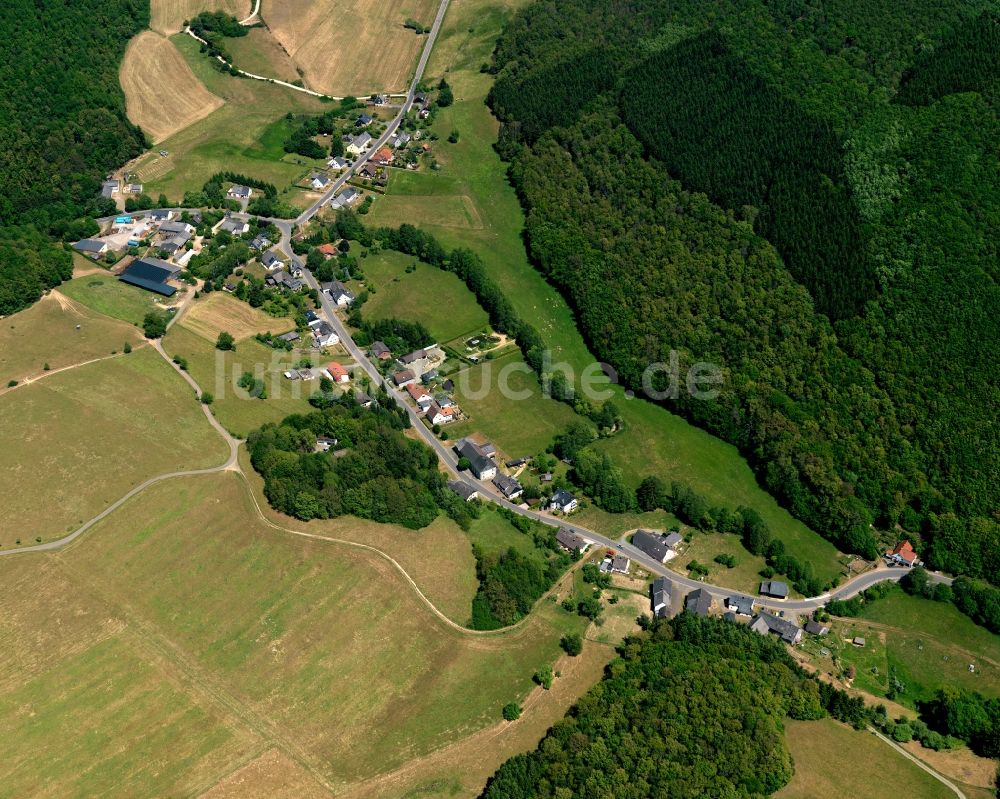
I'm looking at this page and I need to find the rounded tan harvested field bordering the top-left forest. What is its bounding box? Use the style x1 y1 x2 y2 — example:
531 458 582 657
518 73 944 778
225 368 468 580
118 31 223 142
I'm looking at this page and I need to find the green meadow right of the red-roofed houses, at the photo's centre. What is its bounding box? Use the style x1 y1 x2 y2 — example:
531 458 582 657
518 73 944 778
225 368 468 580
448 352 576 458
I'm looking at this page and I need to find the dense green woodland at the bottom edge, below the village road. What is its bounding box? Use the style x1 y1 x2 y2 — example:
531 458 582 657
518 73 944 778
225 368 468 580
483 613 864 799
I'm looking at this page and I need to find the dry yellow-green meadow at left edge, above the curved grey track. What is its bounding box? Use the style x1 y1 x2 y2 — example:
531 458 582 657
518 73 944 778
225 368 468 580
0 348 226 548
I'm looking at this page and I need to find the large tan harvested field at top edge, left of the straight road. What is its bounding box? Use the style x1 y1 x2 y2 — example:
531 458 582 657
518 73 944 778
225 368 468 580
261 0 437 96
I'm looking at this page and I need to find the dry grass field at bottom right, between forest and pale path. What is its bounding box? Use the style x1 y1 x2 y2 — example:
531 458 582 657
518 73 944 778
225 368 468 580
774 718 955 799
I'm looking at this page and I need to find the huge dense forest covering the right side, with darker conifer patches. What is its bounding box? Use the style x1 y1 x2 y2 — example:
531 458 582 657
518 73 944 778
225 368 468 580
490 0 1000 579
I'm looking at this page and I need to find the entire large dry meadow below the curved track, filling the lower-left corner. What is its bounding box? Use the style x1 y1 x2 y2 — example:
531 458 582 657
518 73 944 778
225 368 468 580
0 473 582 795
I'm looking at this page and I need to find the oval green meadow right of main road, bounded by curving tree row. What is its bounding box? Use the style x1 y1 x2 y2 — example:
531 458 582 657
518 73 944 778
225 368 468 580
360 250 489 342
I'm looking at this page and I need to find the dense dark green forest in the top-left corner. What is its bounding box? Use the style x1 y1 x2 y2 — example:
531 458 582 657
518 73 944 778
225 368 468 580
0 0 149 314
